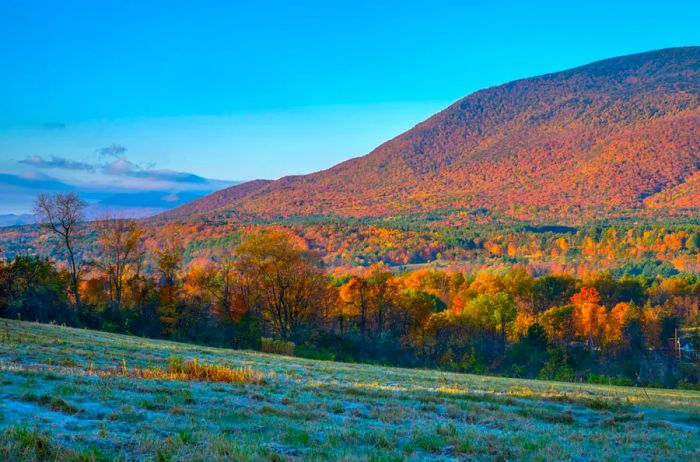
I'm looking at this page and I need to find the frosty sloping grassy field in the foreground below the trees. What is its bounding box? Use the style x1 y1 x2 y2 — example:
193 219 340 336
0 320 700 461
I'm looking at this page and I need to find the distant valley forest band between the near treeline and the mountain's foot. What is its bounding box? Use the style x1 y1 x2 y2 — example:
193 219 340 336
0 216 700 278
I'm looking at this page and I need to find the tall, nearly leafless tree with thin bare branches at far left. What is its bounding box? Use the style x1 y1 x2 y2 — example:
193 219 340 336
34 193 86 310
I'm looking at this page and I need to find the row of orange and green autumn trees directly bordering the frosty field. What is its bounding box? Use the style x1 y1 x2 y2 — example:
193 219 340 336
0 195 700 387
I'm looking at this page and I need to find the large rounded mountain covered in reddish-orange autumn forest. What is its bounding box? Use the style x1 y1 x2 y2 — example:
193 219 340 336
167 47 700 224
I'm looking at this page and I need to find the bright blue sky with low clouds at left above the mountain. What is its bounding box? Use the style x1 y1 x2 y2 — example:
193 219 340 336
0 0 700 214
